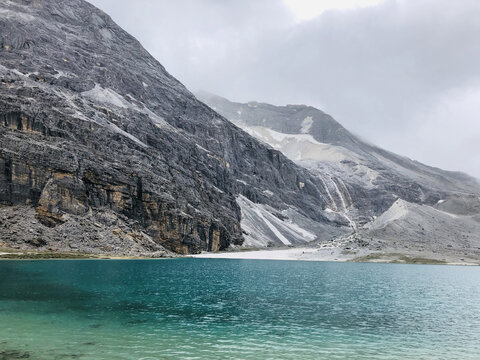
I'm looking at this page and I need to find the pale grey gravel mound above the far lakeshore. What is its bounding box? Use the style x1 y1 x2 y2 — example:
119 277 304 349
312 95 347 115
358 197 480 262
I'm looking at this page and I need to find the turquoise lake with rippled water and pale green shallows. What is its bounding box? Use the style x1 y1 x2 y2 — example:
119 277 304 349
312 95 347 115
0 259 480 360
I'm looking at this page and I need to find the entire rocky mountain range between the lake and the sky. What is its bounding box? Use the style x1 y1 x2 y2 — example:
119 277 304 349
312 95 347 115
0 0 480 260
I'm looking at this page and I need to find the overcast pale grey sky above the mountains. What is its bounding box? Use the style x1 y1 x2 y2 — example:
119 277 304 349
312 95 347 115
91 0 480 177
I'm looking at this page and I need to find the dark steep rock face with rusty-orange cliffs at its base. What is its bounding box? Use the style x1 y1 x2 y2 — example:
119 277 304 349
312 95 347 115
0 0 349 254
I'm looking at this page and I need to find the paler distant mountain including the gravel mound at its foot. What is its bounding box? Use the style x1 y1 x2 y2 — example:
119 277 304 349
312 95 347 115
196 92 480 260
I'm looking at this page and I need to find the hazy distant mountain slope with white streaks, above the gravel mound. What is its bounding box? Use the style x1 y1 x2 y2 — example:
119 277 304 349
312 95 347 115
197 92 480 219
